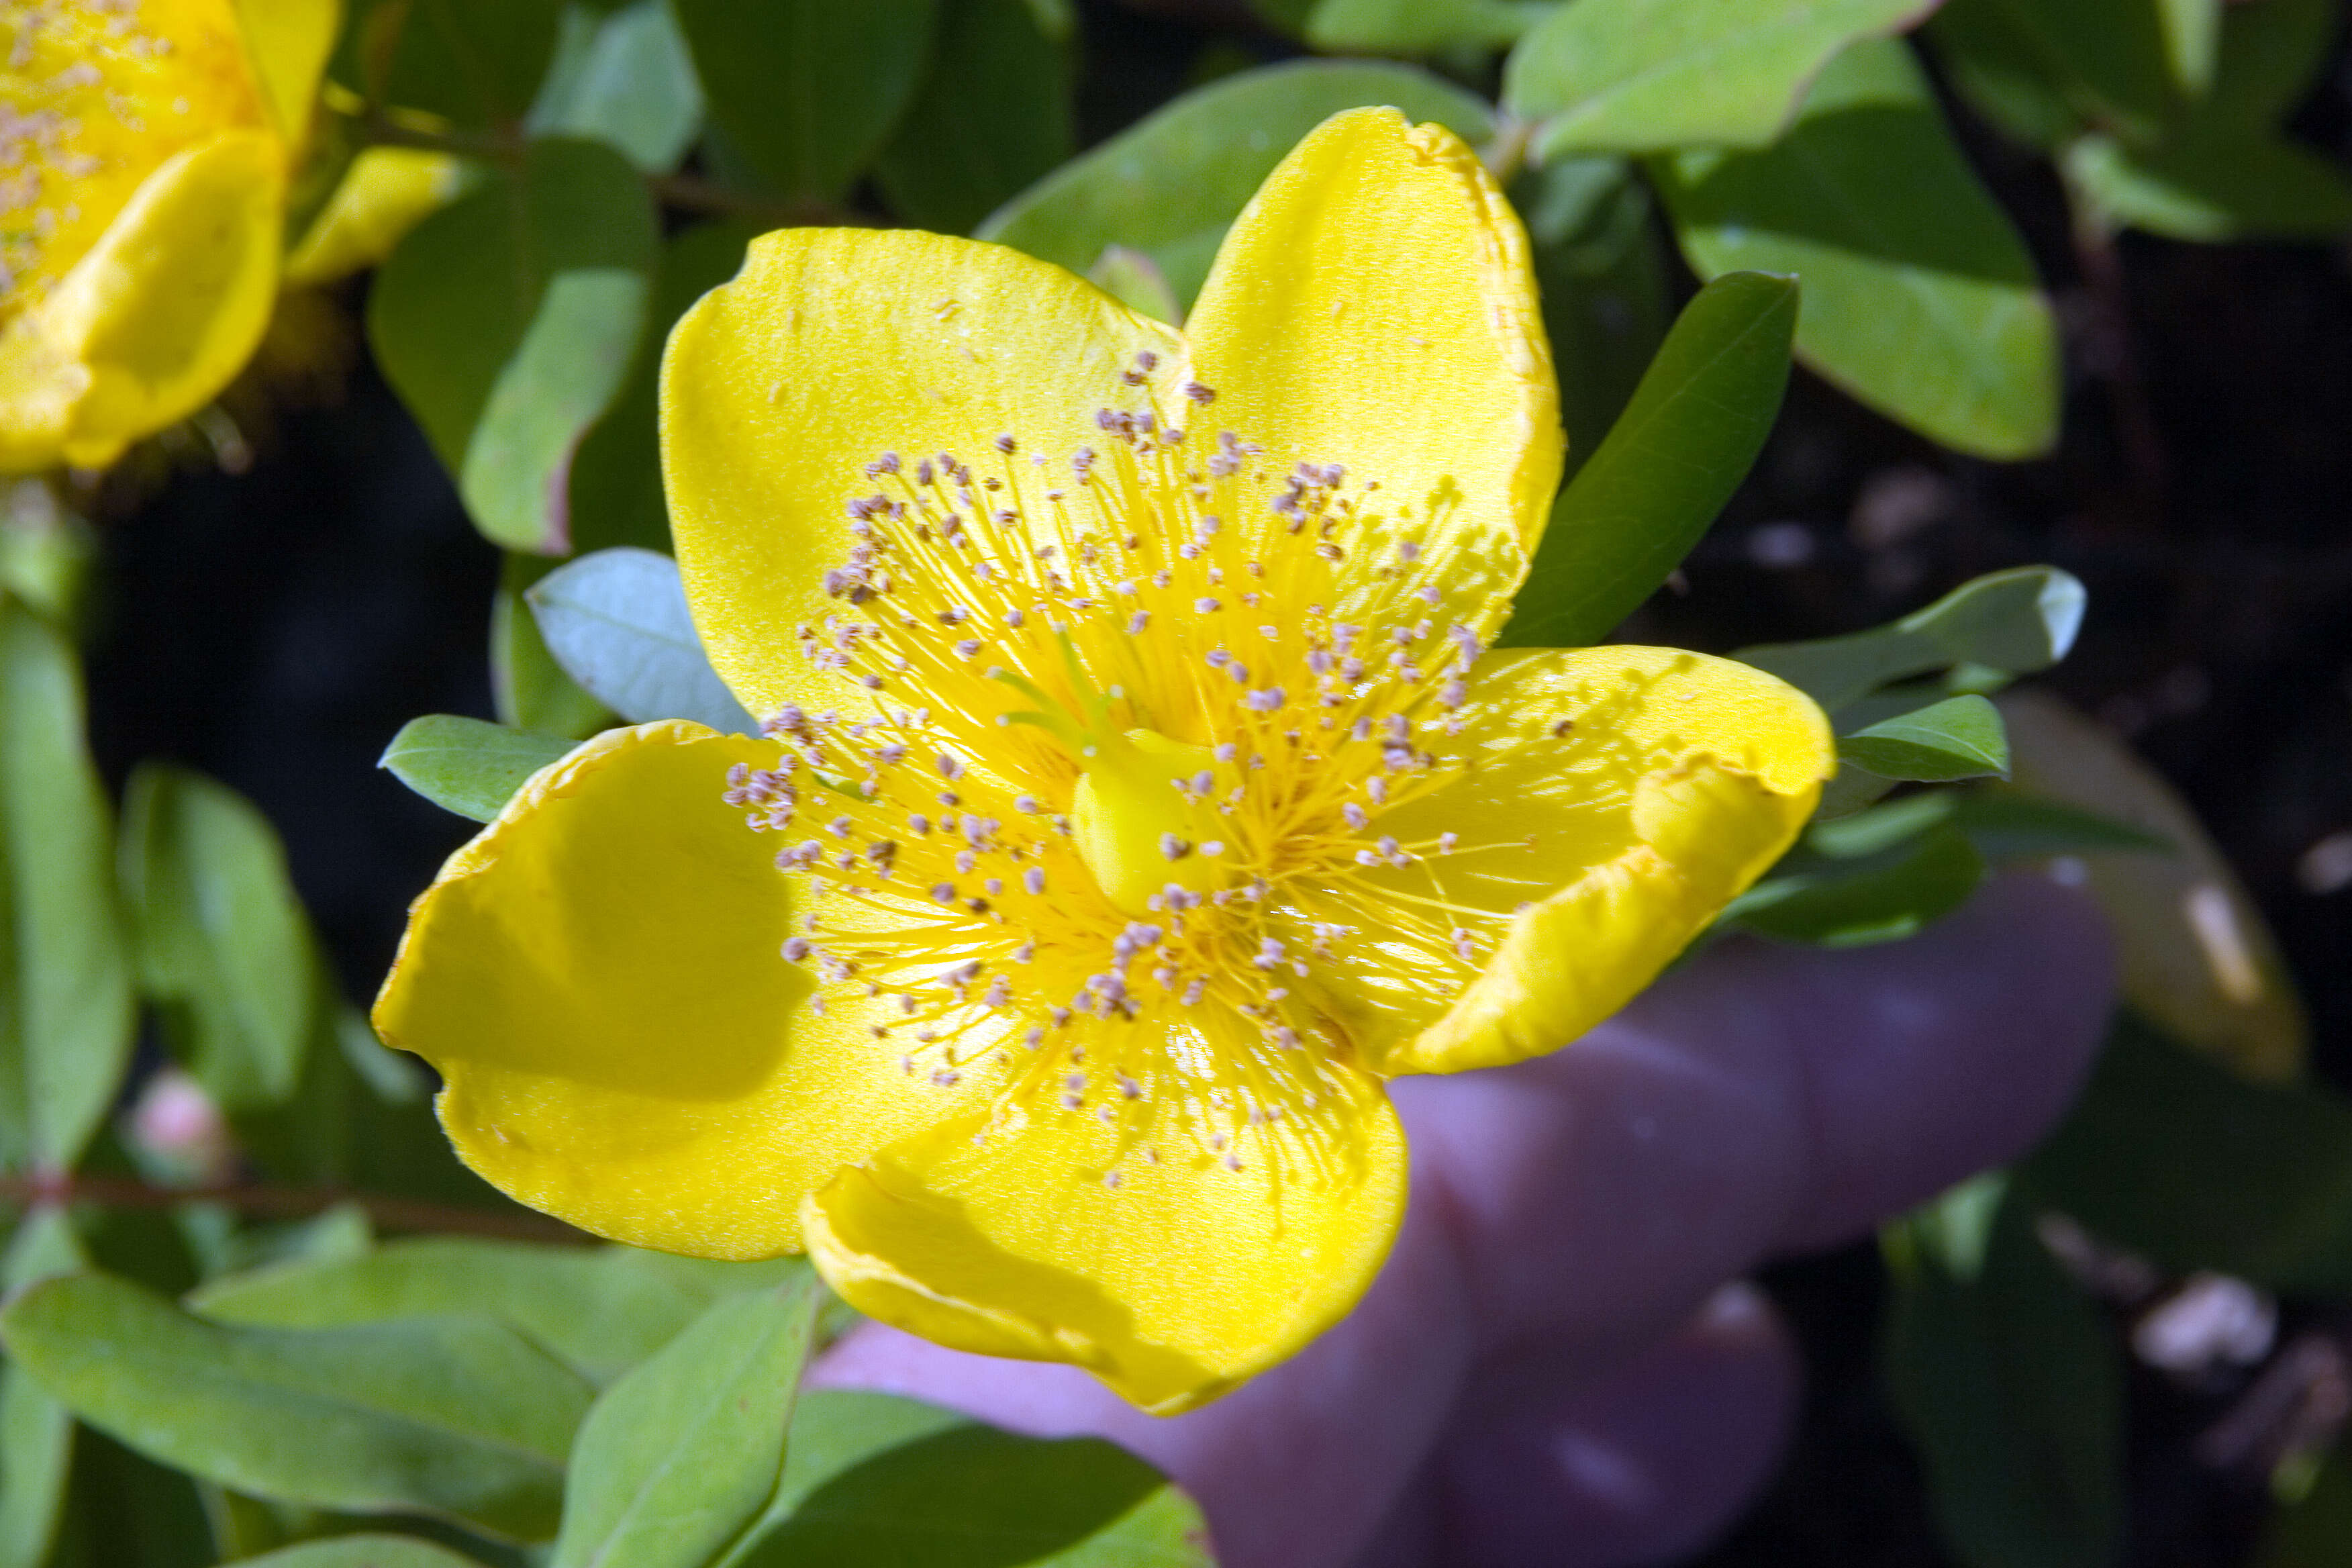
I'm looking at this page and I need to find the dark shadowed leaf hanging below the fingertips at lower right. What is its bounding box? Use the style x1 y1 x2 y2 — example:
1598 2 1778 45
1881 1178 2124 1568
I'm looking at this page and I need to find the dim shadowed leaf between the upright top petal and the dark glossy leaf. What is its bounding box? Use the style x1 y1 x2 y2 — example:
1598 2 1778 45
1510 158 1675 479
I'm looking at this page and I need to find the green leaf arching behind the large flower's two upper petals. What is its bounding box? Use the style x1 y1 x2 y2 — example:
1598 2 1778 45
976 61 1493 308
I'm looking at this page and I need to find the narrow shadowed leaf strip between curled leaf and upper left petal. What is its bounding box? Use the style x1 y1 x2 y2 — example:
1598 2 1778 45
571 221 760 555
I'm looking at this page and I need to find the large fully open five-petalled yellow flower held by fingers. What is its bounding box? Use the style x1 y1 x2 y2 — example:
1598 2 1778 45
377 111 1832 1413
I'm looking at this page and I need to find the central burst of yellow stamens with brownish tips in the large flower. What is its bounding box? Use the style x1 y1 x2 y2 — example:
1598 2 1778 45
727 362 1506 1180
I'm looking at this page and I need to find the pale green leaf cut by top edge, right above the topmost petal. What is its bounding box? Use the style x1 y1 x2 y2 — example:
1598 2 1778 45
1503 0 1933 158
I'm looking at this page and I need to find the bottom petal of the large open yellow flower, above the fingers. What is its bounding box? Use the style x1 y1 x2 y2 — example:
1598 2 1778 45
804 1063 1406 1415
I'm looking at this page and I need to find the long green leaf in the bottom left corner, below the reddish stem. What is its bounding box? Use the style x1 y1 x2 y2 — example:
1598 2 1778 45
0 1274 591 1540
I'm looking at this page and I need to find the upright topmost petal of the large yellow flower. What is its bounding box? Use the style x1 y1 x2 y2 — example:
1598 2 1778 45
1185 108 1562 635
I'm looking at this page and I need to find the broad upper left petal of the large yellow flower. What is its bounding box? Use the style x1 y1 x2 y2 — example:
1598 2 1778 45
661 228 1183 715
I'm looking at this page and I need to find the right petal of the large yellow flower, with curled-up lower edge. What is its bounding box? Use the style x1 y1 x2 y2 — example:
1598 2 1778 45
1301 646 1837 1075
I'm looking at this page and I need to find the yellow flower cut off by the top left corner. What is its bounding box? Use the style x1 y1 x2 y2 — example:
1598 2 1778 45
0 0 449 473
